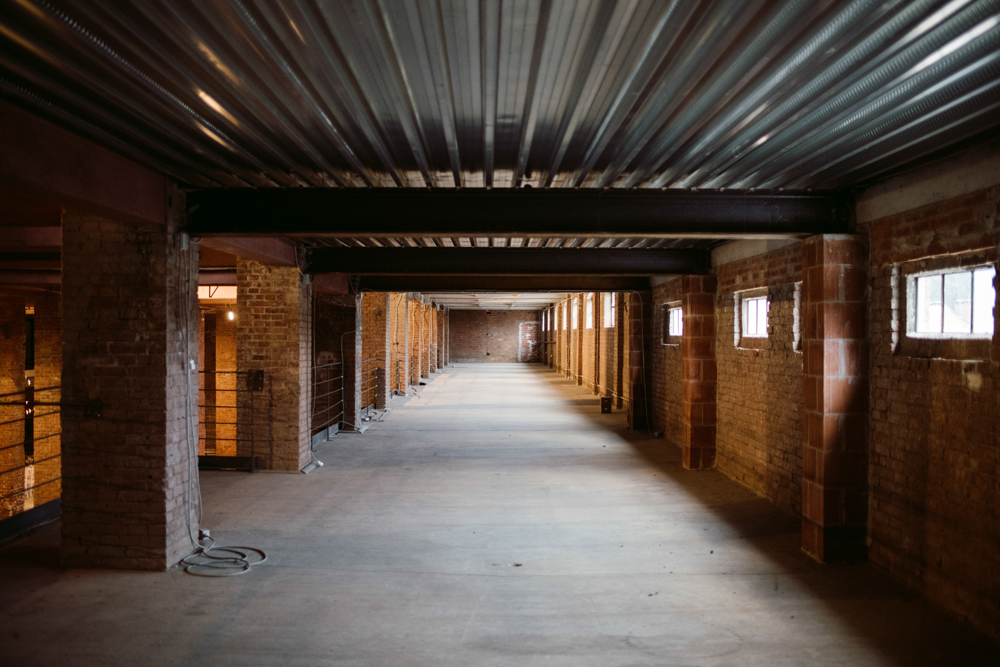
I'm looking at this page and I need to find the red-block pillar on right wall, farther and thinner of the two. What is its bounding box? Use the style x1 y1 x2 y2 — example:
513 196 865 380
681 276 717 470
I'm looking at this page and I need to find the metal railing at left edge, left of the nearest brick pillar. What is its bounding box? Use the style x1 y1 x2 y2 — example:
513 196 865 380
0 386 62 519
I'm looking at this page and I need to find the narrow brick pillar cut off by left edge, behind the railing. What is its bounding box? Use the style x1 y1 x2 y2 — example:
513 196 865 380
0 297 27 520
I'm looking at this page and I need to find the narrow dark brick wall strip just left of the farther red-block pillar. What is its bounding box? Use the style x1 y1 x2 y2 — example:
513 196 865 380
652 278 684 447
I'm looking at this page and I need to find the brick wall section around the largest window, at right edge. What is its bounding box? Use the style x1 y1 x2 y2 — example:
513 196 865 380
865 188 1000 638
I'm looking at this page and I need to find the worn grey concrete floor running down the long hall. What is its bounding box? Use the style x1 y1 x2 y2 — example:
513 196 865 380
0 364 1000 667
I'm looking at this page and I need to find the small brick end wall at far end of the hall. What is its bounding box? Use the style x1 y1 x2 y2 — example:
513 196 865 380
449 310 538 363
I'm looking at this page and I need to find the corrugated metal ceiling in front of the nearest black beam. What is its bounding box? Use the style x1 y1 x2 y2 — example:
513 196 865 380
0 0 1000 192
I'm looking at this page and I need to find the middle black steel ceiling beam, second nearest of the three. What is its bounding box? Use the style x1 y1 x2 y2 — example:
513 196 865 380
305 248 711 276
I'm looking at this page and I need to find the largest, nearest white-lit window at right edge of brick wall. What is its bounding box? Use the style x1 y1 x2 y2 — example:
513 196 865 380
907 266 996 338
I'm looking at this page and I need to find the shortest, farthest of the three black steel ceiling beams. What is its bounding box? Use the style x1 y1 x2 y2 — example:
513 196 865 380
352 276 649 292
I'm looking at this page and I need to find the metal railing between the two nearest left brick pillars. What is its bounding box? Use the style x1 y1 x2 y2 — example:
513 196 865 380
198 371 264 456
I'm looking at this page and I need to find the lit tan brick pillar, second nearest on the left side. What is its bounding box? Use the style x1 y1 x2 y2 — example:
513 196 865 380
236 258 312 470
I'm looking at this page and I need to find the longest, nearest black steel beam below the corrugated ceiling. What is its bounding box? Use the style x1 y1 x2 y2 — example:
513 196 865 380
187 188 853 238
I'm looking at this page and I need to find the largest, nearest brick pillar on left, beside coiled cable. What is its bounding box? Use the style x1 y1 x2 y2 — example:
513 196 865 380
62 209 198 570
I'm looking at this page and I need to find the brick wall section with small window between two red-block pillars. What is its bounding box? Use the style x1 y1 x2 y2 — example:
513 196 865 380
716 244 802 515
